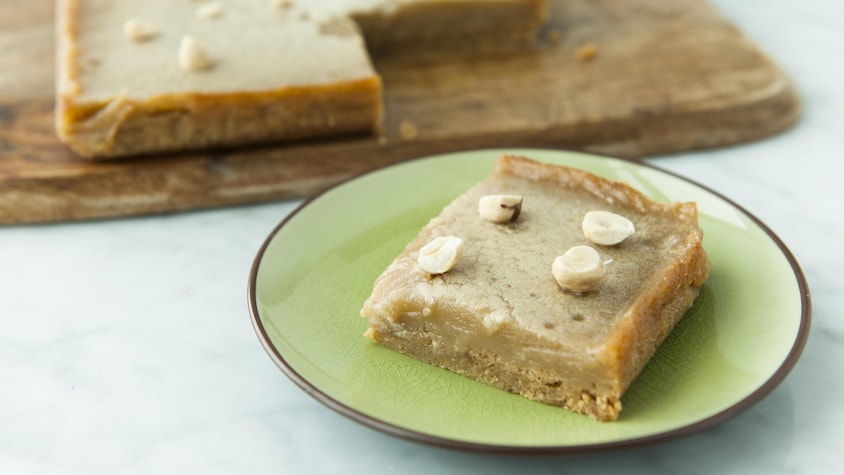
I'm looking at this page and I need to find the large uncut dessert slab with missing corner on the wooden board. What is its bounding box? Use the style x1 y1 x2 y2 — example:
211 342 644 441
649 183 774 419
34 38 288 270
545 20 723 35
56 0 547 159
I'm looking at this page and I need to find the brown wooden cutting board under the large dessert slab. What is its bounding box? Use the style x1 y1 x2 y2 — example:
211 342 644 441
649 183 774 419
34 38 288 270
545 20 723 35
0 0 799 224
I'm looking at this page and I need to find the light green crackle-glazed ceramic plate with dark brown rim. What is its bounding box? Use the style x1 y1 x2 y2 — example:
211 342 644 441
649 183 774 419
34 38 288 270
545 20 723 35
248 149 810 453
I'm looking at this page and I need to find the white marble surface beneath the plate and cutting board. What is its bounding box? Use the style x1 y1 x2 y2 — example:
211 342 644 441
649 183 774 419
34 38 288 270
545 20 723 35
0 0 844 475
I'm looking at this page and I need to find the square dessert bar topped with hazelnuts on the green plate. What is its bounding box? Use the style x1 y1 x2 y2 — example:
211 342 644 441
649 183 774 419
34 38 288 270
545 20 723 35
361 156 709 421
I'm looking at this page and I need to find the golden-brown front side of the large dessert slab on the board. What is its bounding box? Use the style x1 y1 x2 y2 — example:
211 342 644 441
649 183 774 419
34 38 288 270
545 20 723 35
56 76 383 159
